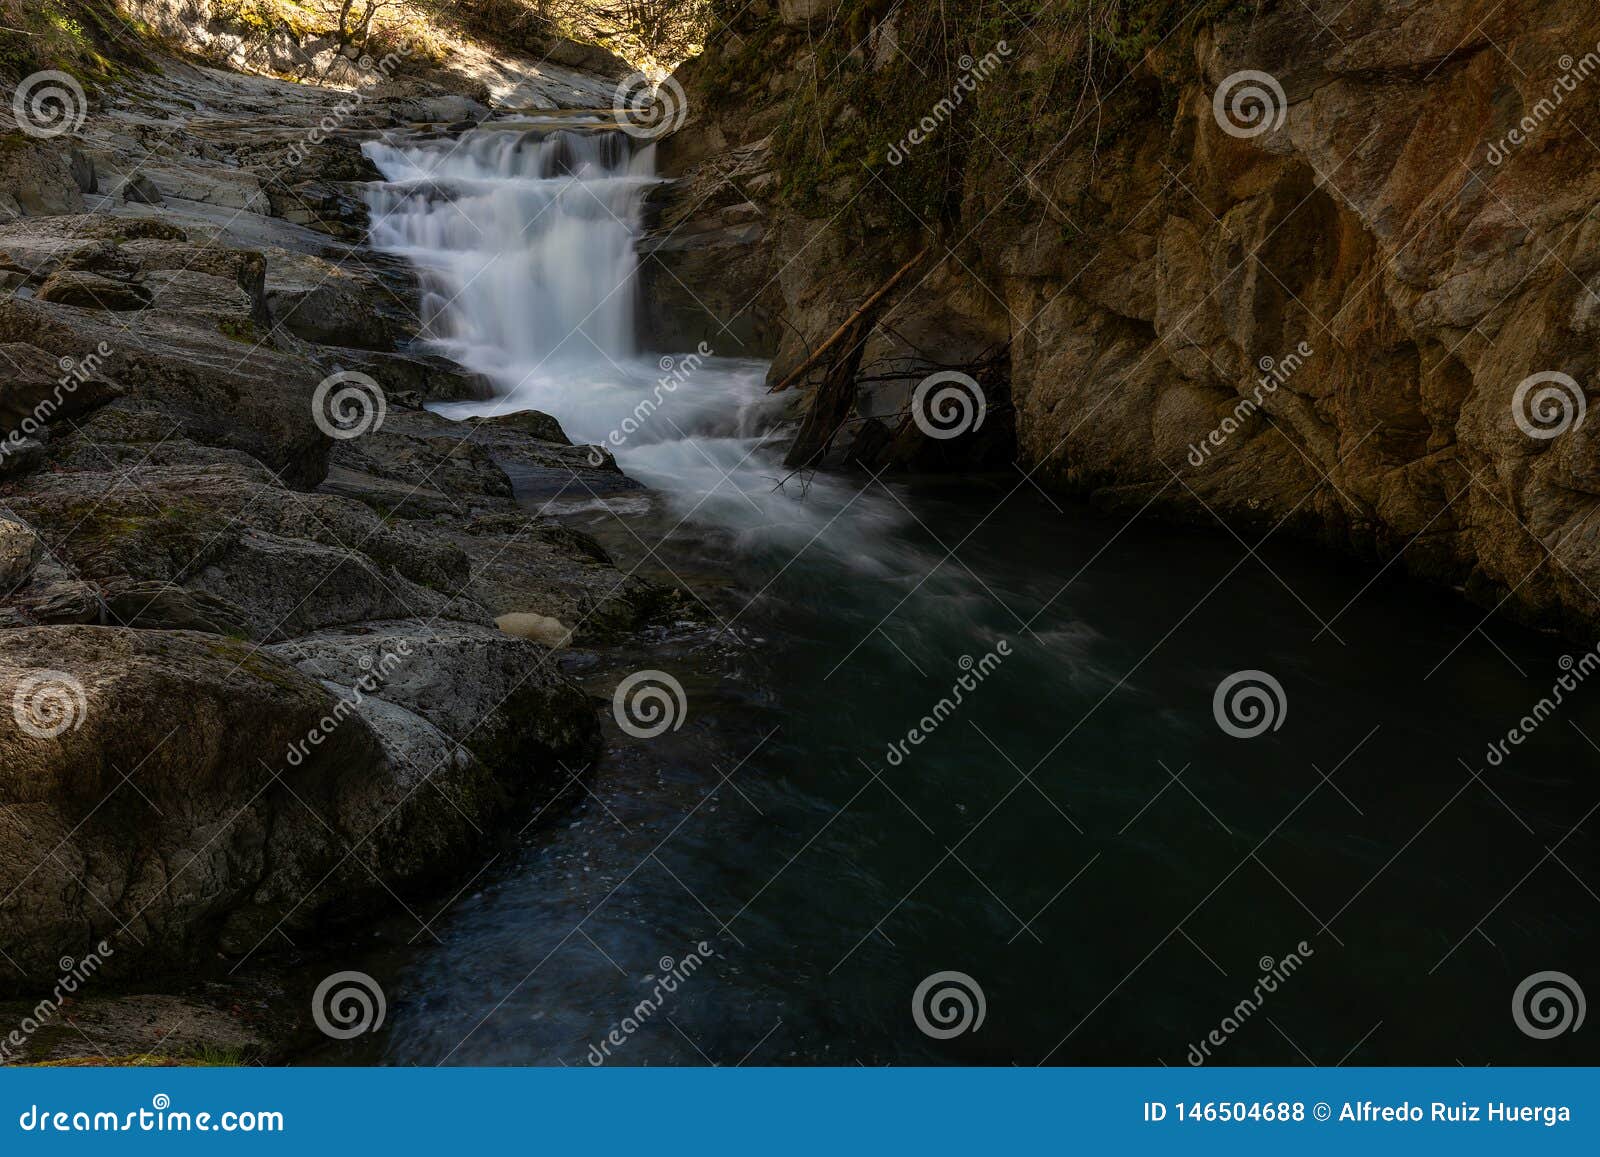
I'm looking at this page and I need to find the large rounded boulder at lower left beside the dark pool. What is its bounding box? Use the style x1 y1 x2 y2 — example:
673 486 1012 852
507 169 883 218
0 624 597 989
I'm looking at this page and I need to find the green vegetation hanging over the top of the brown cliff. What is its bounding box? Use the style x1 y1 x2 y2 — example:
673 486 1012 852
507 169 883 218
713 0 1264 235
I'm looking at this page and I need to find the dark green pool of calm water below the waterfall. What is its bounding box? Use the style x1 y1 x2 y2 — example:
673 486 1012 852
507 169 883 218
339 477 1600 1066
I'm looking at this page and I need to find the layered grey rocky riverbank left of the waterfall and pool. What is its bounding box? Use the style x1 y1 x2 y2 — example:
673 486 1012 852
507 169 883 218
0 20 677 1061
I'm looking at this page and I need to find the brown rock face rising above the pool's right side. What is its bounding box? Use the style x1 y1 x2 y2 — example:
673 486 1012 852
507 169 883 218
654 0 1600 631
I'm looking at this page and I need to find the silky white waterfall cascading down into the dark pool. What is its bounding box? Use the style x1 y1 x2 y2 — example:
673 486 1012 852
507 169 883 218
366 120 901 568
